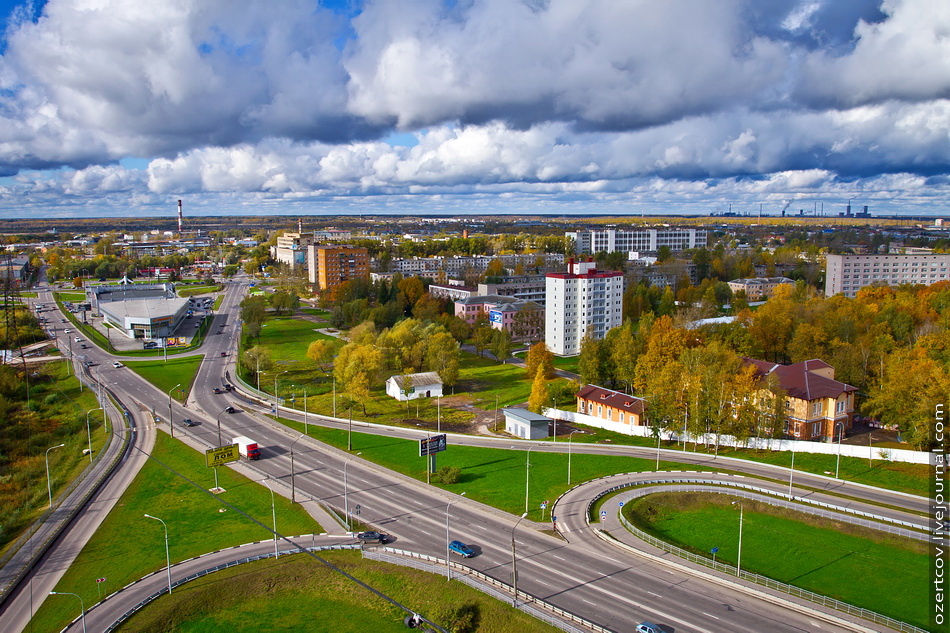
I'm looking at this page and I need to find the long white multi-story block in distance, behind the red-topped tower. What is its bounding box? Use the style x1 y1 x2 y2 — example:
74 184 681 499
565 227 707 255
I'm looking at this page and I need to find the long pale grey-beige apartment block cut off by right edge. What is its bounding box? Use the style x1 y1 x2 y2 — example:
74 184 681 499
825 255 950 297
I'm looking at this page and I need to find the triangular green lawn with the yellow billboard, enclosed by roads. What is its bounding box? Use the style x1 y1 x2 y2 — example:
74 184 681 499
33 433 322 631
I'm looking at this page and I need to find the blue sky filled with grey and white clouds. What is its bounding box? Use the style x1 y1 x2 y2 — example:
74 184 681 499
0 0 950 218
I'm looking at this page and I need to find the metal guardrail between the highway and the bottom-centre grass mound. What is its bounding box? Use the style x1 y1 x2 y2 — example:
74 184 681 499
363 547 614 633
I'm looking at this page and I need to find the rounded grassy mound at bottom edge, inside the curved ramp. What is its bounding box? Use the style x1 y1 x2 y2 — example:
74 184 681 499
119 552 557 633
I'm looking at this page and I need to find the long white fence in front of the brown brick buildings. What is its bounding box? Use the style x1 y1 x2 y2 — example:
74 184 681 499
544 409 933 464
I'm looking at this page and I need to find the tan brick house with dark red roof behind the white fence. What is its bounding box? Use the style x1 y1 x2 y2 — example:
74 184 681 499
744 358 858 442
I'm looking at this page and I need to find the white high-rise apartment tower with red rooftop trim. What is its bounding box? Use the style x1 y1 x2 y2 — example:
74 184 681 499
544 259 623 356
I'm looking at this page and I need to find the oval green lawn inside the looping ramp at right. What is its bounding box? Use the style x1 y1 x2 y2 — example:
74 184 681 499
623 493 930 627
